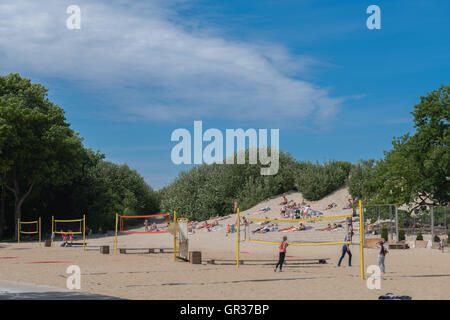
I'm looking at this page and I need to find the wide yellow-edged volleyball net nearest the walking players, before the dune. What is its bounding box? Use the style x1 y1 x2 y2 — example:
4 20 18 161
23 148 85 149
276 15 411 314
243 215 353 246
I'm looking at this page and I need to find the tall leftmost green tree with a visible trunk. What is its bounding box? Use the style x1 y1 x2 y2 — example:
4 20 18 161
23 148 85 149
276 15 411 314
0 74 85 238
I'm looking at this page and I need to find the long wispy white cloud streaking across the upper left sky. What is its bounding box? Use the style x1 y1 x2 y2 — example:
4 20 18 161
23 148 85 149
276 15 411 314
0 0 342 126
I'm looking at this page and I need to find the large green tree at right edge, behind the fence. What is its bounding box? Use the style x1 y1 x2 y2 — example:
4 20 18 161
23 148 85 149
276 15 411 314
377 85 450 207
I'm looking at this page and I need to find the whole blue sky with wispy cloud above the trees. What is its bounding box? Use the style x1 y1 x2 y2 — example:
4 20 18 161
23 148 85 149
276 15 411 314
0 0 450 189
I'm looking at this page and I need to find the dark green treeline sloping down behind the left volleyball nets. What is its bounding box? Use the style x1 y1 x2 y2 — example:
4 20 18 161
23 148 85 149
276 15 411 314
0 74 159 239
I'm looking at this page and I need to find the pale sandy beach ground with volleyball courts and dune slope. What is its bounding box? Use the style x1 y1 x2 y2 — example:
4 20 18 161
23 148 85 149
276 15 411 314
0 188 450 300
